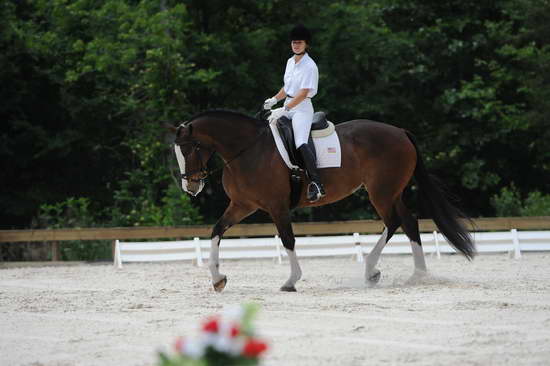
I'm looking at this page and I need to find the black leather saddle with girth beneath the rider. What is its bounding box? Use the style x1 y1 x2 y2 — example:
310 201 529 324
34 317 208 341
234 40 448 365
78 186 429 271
277 112 329 209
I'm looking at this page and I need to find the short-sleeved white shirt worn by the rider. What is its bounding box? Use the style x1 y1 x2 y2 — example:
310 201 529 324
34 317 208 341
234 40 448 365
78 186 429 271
284 53 319 98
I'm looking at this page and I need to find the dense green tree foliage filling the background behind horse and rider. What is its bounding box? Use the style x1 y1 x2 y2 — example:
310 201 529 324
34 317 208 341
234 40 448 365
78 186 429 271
0 0 550 233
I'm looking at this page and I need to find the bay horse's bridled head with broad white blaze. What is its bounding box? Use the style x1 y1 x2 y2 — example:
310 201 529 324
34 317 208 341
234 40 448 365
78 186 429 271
174 123 214 196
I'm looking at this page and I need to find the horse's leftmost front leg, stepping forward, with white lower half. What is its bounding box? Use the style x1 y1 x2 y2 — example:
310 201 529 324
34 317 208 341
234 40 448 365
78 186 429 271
208 201 256 292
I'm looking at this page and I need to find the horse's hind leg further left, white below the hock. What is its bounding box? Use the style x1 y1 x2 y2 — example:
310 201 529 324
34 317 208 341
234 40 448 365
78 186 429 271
365 199 400 285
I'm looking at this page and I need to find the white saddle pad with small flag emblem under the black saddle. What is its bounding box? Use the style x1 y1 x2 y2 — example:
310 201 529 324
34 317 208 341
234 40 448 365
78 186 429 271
269 122 342 169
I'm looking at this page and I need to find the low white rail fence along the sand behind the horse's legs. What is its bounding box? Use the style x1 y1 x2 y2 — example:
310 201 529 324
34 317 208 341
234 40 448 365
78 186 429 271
114 229 550 268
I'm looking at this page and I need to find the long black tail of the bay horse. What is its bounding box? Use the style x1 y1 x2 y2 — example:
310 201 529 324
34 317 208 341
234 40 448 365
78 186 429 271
405 131 476 260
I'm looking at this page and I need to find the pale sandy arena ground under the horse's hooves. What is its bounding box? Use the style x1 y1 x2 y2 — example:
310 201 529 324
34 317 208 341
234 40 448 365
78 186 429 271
0 253 550 366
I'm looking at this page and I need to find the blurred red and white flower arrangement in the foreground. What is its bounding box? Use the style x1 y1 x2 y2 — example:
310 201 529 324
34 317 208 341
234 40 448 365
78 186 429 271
159 304 267 366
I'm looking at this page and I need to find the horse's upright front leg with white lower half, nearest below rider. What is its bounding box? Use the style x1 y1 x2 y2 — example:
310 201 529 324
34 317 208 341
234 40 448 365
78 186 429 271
271 210 302 292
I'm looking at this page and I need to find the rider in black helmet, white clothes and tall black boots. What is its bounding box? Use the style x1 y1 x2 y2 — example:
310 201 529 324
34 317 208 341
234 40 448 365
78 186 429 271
264 25 325 202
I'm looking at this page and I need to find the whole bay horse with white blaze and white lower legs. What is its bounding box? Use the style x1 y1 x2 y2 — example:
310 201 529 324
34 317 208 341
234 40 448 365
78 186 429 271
171 110 475 292
